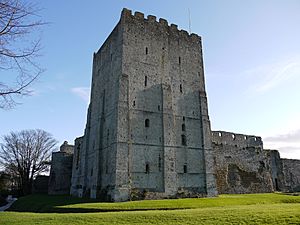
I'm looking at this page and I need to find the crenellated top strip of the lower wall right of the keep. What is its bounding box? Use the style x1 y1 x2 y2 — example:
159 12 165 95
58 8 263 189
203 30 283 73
212 131 263 148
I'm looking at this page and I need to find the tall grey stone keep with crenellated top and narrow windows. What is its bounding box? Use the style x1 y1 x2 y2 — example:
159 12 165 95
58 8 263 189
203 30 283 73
71 9 217 201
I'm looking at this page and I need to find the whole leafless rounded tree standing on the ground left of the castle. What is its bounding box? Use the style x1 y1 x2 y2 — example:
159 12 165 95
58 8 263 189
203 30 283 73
0 129 57 195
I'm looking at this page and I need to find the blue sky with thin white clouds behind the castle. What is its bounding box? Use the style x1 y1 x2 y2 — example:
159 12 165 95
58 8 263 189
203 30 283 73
0 0 300 159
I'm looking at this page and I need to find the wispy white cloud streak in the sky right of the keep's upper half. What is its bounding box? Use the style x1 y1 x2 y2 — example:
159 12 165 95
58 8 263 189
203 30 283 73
245 56 300 93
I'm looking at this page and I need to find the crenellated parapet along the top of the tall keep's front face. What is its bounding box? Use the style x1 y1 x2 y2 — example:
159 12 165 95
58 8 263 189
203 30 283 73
121 8 201 41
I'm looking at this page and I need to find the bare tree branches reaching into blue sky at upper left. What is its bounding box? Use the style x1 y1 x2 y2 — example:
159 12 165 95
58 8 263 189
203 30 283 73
0 0 44 109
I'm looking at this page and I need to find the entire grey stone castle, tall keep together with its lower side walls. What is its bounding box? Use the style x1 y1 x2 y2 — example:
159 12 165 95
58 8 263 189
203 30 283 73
49 9 300 201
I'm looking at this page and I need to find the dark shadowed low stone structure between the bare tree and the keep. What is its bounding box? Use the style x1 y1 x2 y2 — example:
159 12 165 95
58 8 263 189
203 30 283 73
48 141 74 195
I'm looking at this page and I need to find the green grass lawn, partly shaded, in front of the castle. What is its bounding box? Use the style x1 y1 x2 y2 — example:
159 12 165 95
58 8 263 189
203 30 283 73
0 194 300 225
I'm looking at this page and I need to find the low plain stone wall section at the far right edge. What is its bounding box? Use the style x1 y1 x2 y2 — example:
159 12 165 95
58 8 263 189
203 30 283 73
281 159 300 192
